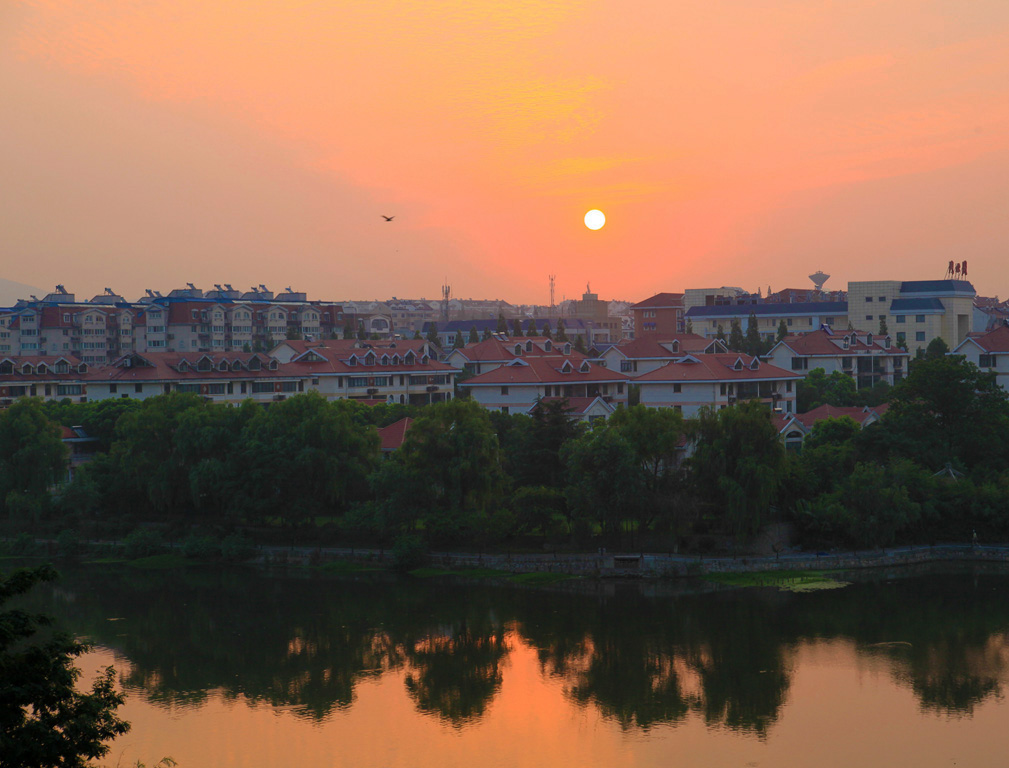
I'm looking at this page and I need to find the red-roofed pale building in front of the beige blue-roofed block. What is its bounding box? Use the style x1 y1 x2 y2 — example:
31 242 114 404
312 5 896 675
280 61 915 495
767 327 910 390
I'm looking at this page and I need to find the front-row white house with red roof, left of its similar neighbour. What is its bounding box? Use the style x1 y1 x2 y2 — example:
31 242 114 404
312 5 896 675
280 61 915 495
459 356 630 414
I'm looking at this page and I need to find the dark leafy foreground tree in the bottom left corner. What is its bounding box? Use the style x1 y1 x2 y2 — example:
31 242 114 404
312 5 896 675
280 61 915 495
0 565 129 768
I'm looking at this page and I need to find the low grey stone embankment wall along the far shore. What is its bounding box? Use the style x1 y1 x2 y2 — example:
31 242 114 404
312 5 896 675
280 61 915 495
262 544 1009 578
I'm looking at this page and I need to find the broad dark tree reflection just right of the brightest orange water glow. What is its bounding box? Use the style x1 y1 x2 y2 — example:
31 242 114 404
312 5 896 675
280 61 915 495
521 594 790 734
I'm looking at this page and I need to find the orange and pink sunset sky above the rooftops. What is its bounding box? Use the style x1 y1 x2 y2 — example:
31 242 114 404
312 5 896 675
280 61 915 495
0 0 1009 304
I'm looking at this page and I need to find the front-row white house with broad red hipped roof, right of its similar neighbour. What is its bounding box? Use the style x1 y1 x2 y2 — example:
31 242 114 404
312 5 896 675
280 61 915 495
634 353 802 418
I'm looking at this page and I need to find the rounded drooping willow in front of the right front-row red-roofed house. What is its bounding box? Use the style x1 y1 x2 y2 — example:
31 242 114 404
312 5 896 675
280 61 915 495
689 401 785 540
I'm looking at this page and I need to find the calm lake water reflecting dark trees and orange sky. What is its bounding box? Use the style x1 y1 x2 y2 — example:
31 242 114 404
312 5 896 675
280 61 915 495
19 566 1009 768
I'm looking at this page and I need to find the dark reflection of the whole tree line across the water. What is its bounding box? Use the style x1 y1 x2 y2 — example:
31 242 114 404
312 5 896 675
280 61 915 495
17 566 1009 738
